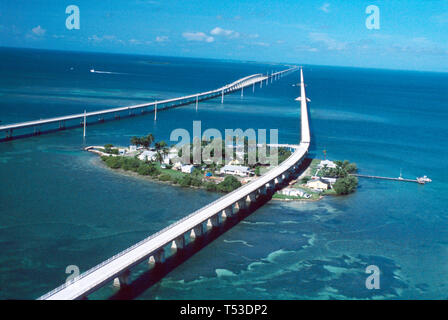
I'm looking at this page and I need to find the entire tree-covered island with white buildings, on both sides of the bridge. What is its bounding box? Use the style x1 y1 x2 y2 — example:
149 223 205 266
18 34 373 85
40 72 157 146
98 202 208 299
86 134 358 201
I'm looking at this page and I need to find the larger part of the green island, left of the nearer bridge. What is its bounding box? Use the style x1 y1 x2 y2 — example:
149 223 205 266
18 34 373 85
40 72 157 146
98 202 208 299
85 134 291 193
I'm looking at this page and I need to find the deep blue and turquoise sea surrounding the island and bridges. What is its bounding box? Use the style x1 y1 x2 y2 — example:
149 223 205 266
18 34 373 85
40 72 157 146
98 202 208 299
0 49 448 299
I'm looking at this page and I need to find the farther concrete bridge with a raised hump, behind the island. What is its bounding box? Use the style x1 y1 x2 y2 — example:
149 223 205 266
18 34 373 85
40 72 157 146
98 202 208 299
0 67 298 141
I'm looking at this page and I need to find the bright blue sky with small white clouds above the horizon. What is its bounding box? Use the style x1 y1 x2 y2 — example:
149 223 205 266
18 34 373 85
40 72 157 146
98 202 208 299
0 0 448 72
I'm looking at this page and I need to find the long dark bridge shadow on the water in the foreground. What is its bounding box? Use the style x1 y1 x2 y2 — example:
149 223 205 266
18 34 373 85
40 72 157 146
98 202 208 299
109 192 273 300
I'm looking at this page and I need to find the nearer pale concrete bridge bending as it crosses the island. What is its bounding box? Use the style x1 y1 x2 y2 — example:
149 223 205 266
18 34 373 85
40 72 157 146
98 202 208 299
39 70 310 300
